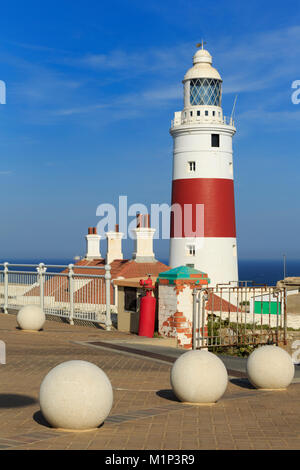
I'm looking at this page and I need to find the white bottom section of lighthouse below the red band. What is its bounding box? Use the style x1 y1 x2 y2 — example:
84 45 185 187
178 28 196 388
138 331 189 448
169 237 238 287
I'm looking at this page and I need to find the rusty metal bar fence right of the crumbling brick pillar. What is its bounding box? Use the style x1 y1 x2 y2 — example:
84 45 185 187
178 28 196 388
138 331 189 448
193 281 287 350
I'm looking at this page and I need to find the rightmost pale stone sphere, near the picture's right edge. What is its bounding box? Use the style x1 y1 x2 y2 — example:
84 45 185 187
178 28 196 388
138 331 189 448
247 345 295 389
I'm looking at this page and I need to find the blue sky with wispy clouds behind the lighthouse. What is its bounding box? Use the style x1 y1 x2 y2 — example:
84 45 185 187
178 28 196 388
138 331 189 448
0 0 300 260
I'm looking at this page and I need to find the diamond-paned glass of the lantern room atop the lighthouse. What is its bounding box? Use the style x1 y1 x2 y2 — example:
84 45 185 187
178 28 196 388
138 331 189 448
190 78 221 106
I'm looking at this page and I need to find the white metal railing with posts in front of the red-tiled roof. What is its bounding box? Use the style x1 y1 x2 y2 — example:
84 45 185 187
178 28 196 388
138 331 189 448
0 262 116 330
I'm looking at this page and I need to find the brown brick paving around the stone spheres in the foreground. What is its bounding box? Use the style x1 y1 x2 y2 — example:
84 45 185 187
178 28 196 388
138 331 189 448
0 314 300 450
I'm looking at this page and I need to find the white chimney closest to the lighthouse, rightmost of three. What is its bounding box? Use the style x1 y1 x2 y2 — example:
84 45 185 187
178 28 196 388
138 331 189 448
132 214 156 263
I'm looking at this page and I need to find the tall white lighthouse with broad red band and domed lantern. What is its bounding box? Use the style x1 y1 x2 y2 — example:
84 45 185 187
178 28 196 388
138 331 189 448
170 42 238 286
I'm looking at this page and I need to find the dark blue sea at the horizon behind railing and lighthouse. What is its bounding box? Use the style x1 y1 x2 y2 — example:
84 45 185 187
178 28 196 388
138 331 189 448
0 258 300 286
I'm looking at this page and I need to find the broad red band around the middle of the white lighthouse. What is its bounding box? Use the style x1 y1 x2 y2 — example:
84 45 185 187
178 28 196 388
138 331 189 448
171 178 236 238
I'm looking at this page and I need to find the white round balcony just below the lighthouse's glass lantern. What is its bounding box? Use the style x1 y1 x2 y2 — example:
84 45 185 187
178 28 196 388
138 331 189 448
171 108 234 129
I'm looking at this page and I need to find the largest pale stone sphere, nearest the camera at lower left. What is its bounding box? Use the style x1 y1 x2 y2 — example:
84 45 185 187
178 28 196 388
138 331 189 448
39 361 113 430
